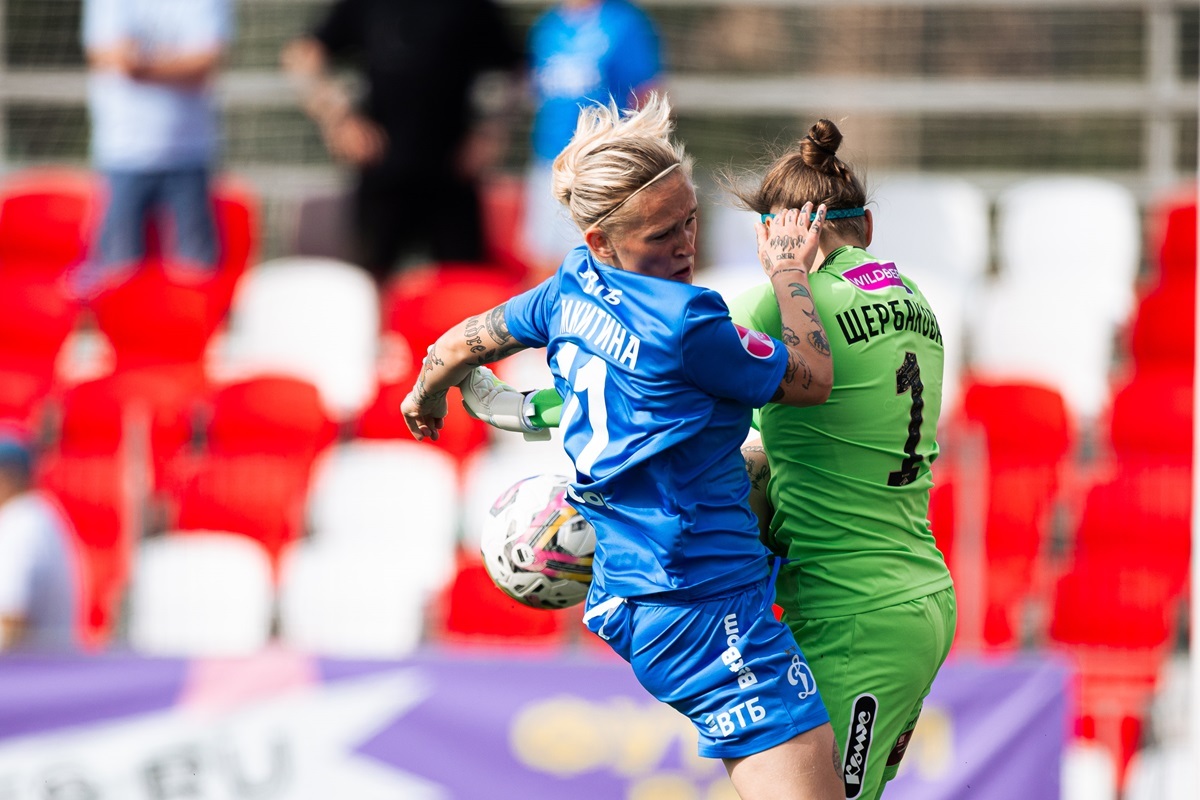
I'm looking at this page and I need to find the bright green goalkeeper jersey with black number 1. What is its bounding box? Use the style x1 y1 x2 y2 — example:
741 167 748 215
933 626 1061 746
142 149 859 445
730 247 952 619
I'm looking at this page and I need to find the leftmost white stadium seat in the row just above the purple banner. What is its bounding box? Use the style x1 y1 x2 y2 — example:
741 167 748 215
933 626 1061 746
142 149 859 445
128 530 275 657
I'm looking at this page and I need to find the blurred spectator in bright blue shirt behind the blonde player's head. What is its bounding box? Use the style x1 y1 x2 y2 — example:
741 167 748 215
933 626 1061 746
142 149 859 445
523 0 661 271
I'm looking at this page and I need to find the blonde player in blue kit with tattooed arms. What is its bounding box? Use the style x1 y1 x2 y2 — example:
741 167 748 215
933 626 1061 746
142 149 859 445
402 95 844 800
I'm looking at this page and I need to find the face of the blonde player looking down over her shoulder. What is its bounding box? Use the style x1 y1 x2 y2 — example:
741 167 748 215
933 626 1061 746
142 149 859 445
599 170 697 283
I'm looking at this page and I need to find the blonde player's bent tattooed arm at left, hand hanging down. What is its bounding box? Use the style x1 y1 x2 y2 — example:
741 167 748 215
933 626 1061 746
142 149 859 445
401 305 526 441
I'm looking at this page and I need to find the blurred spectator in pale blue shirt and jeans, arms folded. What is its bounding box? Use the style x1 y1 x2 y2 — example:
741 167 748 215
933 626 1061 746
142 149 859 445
70 0 233 297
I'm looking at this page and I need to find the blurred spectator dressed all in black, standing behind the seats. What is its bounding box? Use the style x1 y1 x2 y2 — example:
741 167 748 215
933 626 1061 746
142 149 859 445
281 0 523 283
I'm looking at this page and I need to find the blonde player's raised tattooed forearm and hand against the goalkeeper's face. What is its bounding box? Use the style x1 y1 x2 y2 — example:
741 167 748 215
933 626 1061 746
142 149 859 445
755 203 833 405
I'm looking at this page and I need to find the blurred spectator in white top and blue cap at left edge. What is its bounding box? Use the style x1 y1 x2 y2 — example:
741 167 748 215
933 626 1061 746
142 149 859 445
0 431 80 649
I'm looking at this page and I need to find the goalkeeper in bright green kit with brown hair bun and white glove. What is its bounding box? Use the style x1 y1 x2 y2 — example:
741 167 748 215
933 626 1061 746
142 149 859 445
462 120 956 800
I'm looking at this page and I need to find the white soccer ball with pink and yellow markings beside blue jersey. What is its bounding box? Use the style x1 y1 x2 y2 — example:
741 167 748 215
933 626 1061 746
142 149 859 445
480 475 596 609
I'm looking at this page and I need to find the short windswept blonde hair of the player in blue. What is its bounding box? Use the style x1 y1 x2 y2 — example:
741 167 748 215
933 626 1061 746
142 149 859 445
551 94 692 230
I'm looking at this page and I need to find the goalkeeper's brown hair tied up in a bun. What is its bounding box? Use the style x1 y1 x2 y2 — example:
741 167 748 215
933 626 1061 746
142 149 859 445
726 120 866 240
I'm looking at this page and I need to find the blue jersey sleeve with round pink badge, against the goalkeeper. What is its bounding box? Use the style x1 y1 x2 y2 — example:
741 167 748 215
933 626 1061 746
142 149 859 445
680 291 787 408
